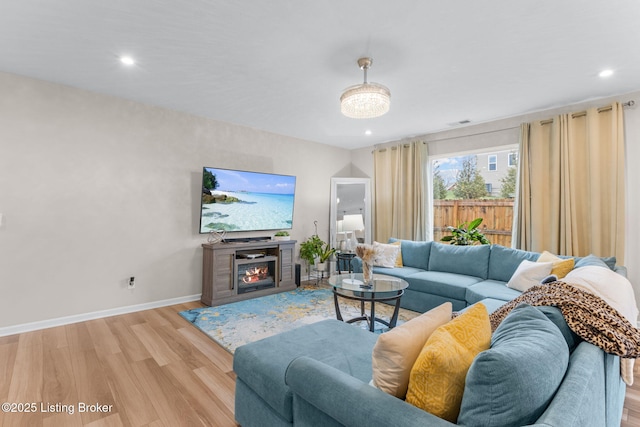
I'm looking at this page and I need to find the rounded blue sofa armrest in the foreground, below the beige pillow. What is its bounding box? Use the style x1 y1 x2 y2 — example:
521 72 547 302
285 356 455 427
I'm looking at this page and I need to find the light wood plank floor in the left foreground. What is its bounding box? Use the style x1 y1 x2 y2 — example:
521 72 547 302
0 302 640 427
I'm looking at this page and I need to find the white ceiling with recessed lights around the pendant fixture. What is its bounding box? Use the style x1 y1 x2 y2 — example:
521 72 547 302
0 0 640 148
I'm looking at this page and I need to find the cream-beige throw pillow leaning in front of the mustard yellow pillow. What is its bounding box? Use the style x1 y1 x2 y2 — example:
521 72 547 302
371 302 452 399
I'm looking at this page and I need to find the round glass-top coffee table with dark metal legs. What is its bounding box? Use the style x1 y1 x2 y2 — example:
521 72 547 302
329 273 409 332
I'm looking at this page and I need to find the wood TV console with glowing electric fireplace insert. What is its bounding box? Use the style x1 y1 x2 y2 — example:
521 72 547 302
201 240 296 306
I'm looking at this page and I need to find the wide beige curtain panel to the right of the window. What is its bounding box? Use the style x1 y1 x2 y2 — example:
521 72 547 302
514 103 625 264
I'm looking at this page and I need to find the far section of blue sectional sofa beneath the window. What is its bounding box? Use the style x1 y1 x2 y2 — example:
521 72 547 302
351 239 626 313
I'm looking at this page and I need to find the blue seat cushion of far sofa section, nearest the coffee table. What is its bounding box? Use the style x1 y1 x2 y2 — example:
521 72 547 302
405 271 481 301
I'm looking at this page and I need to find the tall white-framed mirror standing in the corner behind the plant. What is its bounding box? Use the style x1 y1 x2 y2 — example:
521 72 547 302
329 178 371 252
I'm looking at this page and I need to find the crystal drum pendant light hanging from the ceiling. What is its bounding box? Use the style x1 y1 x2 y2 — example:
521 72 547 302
340 58 391 119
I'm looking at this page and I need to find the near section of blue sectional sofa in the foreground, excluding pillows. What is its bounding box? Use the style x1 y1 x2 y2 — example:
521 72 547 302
233 316 626 427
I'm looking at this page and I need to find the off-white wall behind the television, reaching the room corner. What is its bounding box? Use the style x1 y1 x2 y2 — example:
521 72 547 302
0 73 351 327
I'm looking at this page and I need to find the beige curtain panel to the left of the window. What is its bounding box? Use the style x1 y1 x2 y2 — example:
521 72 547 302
373 141 427 242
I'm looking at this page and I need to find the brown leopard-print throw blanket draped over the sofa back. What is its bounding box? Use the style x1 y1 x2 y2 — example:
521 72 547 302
490 282 640 385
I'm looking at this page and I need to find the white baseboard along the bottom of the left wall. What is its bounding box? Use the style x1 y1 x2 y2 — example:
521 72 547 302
0 294 201 337
